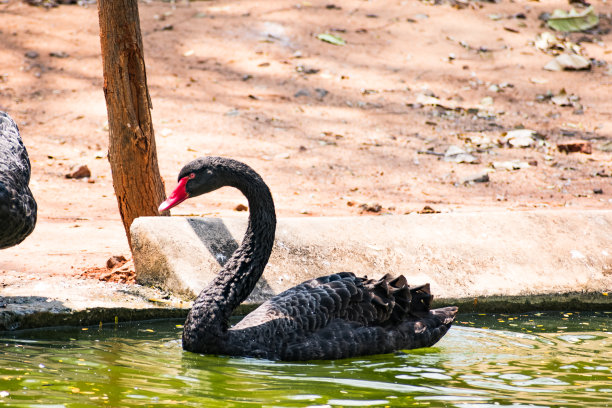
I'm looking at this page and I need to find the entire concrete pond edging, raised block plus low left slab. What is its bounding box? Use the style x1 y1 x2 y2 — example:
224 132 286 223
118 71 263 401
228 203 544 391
0 211 612 331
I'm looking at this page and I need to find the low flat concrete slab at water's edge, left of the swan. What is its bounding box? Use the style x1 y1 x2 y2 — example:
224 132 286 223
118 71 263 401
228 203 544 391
0 271 191 331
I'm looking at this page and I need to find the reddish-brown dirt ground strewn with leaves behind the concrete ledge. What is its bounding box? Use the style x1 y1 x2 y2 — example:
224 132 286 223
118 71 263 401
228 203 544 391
0 0 612 279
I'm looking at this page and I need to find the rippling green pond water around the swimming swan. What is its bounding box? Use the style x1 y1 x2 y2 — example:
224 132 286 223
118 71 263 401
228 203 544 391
0 312 612 408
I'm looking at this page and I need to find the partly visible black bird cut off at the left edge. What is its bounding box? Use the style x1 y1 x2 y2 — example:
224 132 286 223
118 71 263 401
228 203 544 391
0 112 36 249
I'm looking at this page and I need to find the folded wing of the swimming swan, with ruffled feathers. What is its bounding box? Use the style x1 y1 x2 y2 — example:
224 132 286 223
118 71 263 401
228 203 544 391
232 272 444 338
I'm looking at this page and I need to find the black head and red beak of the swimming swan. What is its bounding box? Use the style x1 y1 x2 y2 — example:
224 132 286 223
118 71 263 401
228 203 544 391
159 157 233 212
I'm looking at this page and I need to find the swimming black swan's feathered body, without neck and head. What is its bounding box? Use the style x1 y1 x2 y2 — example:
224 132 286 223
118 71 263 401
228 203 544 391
225 272 457 360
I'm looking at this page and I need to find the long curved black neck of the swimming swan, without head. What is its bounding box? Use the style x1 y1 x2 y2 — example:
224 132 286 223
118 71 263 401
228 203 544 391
183 169 276 352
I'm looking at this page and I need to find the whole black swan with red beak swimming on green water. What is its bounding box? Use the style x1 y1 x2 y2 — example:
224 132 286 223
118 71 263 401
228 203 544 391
159 157 457 361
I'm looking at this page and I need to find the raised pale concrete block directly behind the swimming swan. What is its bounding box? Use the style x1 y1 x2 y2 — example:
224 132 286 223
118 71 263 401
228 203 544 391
131 210 612 303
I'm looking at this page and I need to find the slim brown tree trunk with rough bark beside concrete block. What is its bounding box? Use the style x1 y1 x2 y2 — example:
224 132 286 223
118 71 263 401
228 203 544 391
98 0 166 248
